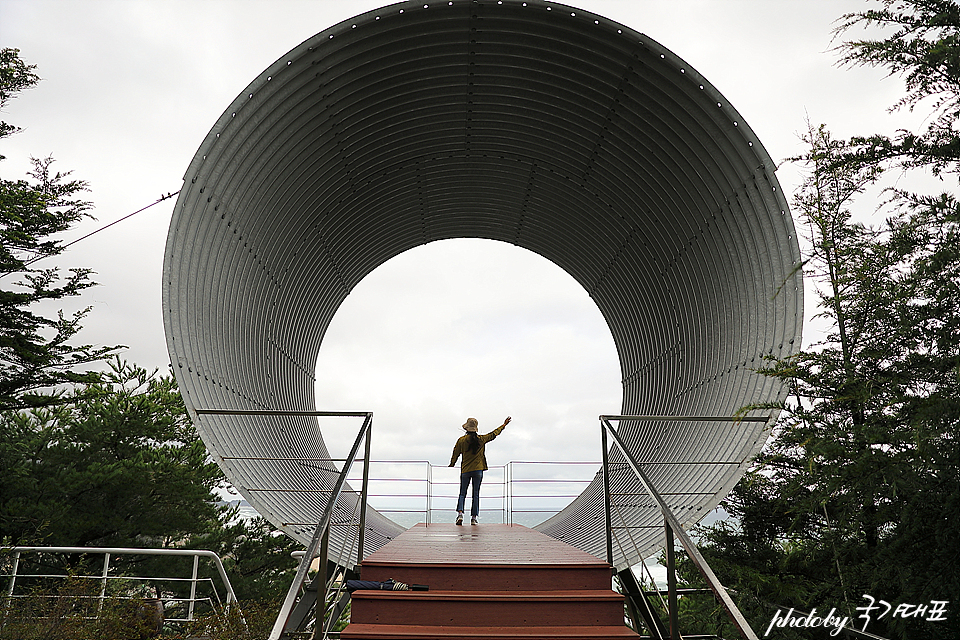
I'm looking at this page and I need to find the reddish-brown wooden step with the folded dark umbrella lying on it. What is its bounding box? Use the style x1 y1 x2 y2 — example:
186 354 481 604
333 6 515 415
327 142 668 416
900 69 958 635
350 589 623 627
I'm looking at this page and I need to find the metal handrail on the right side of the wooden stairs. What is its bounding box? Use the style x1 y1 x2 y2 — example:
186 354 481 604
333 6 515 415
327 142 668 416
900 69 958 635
600 416 770 640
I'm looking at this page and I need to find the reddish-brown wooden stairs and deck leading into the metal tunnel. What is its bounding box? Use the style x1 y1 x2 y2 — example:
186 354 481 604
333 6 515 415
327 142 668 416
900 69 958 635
341 524 637 640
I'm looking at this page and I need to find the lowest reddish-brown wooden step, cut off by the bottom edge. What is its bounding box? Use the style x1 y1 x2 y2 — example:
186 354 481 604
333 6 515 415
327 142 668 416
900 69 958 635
340 623 637 640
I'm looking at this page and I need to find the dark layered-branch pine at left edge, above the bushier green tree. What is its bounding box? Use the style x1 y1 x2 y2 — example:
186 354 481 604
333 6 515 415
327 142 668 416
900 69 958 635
0 49 117 410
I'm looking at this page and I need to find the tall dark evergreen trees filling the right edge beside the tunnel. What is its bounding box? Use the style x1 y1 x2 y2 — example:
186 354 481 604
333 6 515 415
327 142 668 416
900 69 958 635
672 0 960 639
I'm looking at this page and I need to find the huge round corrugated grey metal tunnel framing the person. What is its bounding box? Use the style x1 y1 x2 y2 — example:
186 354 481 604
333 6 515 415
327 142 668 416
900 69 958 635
163 0 802 568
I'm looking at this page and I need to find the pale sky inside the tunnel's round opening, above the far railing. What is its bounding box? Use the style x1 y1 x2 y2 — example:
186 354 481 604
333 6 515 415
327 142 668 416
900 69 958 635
315 238 622 464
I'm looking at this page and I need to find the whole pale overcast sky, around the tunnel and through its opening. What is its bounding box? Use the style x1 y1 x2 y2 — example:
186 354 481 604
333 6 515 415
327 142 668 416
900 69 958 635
0 0 928 480
